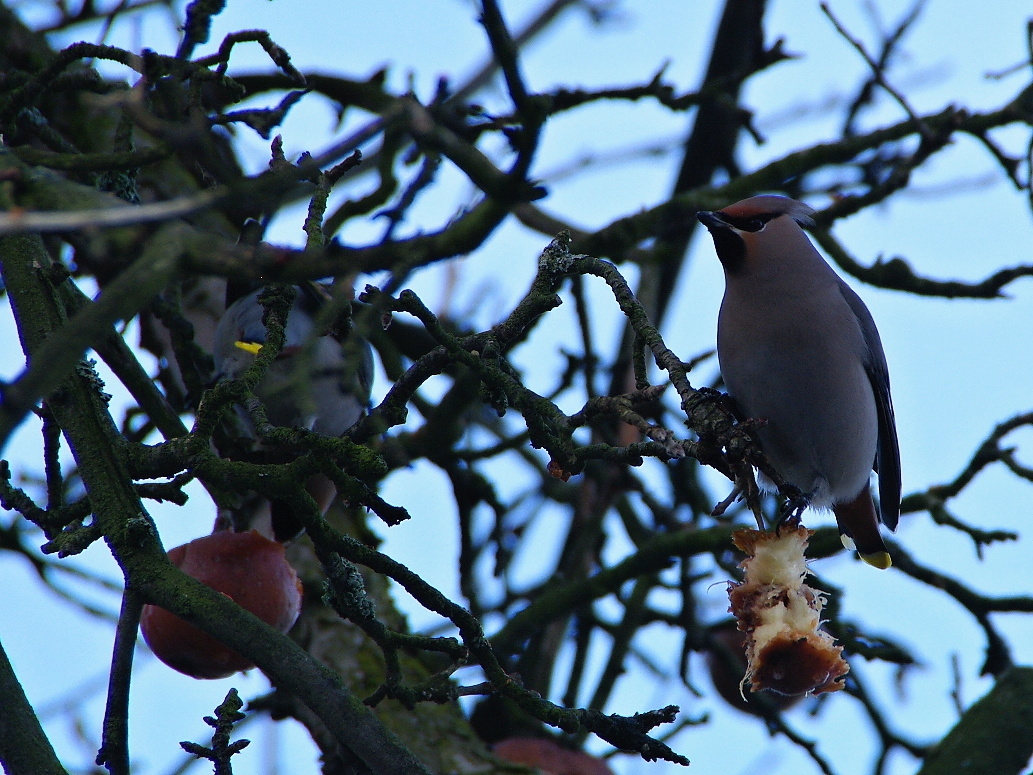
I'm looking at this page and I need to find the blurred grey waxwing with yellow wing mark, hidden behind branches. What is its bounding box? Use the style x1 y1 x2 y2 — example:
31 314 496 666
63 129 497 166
214 283 373 541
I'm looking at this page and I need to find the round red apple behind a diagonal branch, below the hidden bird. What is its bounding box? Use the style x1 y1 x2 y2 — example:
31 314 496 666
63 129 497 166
140 530 302 678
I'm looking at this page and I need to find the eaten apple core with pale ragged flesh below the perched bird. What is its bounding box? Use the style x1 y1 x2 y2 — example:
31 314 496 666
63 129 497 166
728 526 850 695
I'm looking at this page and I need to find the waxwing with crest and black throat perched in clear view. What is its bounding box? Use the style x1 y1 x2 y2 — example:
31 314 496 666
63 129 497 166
696 195 901 568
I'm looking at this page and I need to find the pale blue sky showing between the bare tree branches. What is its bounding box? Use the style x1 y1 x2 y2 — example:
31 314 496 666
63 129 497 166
0 0 1033 775
